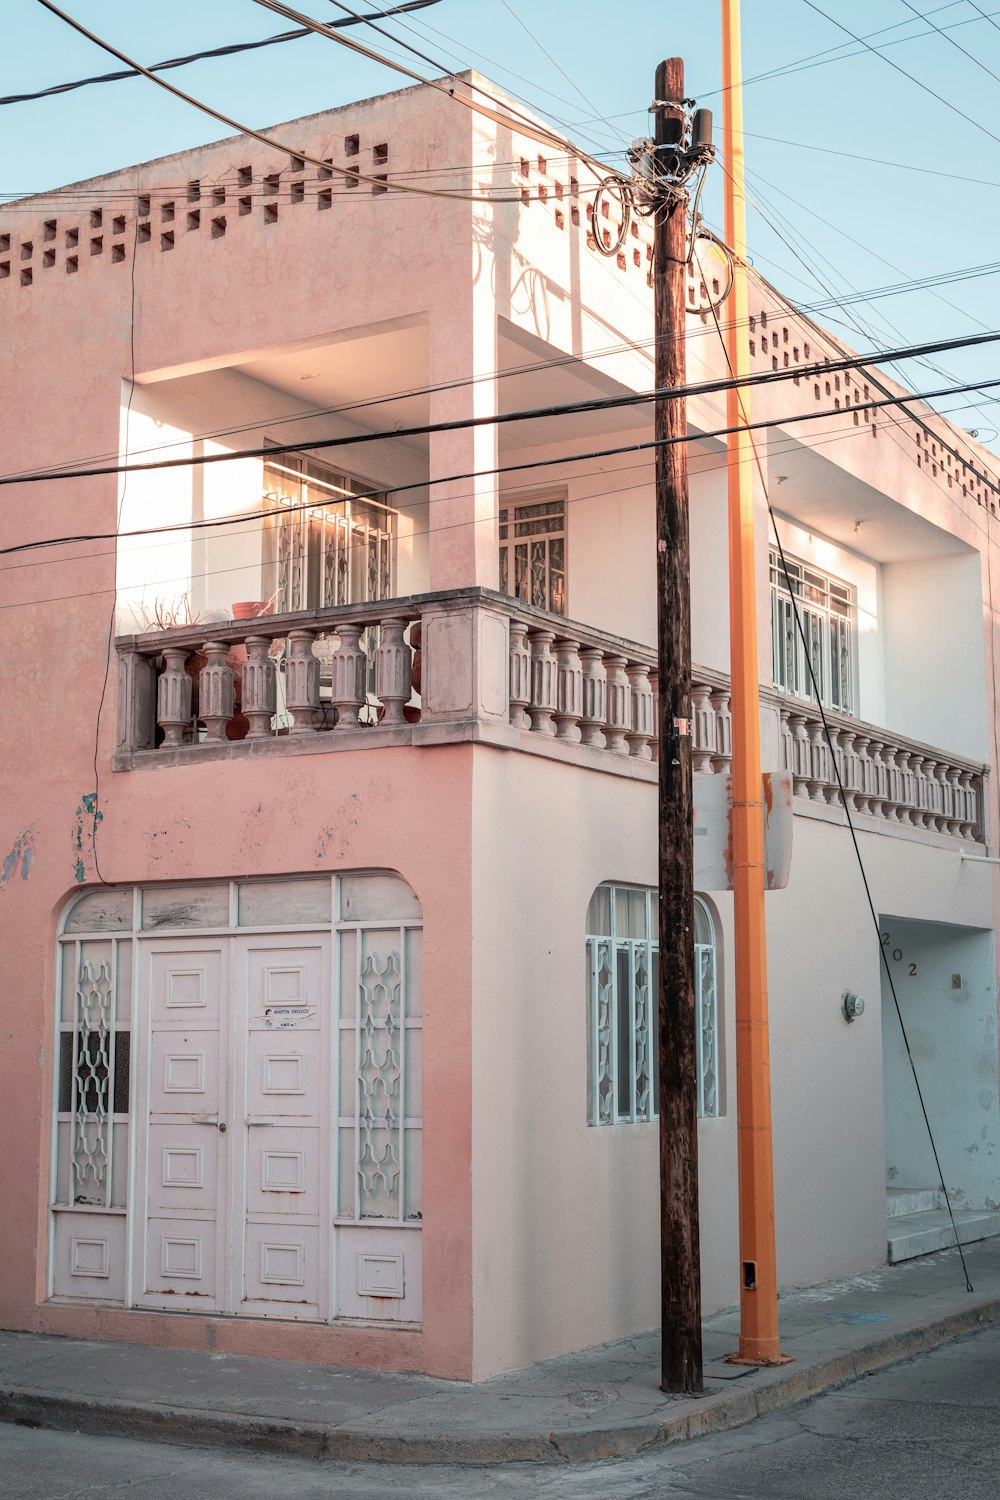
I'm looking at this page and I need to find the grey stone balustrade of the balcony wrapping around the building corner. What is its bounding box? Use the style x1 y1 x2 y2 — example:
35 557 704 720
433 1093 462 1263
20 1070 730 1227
114 588 988 843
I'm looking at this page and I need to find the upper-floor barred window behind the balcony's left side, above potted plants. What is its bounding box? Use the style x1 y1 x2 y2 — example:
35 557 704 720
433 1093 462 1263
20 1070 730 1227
264 452 394 614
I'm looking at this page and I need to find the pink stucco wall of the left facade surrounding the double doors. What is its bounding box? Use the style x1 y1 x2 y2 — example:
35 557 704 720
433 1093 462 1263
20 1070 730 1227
0 79 485 1377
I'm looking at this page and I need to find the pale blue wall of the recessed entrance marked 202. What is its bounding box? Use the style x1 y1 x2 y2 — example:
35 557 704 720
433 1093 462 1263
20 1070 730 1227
882 917 1000 1208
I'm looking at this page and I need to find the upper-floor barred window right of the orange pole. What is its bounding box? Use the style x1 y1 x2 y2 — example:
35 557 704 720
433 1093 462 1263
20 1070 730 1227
771 548 858 714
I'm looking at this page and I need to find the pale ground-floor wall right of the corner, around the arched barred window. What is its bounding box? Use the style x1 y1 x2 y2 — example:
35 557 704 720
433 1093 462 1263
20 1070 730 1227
472 747 996 1377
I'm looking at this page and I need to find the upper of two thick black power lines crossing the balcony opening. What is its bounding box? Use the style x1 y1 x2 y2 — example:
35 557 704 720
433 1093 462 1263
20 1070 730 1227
0 332 1000 494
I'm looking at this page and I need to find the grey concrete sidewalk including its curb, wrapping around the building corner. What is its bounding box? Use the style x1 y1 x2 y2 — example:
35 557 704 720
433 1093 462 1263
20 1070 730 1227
0 1239 1000 1464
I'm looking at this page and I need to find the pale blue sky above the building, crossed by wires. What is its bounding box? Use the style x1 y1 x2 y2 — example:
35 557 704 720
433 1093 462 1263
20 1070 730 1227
0 0 1000 453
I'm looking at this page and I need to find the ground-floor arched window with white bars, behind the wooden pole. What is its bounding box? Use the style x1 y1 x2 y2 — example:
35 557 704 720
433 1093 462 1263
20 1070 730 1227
586 884 720 1125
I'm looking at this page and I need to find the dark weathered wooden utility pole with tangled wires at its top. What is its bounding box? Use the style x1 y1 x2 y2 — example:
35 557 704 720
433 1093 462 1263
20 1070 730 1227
652 57 702 1392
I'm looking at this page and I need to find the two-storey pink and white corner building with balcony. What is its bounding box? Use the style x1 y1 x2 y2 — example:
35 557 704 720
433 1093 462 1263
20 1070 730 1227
0 78 1000 1379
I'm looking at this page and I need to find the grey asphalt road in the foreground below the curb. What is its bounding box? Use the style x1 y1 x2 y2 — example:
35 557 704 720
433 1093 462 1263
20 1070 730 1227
0 1329 1000 1500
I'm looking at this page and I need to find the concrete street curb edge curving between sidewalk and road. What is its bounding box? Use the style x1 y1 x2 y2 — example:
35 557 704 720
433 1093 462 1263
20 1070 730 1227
0 1298 1000 1464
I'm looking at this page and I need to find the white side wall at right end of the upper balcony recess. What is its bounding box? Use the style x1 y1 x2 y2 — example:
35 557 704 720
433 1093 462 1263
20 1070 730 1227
882 552 990 761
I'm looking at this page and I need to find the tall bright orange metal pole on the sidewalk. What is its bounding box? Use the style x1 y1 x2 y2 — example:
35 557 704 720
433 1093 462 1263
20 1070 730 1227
723 0 781 1364
